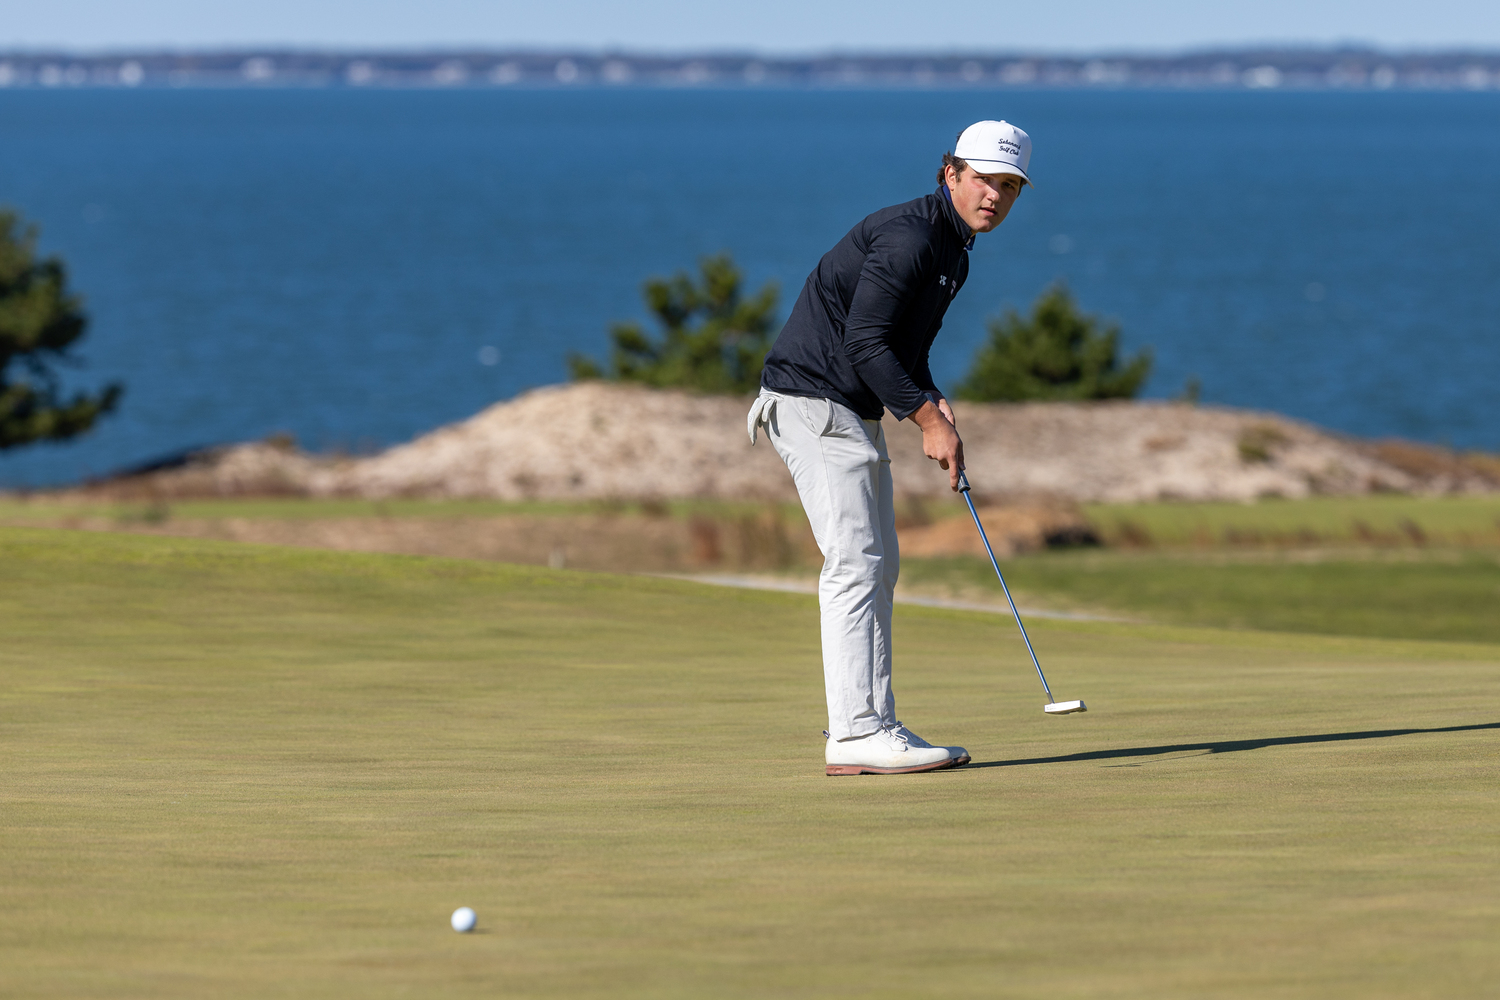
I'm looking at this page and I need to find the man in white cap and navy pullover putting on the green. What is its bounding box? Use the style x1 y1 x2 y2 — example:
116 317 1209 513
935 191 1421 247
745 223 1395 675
749 121 1031 775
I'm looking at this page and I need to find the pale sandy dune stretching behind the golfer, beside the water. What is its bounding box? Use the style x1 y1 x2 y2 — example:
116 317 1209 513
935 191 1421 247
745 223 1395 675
73 382 1500 502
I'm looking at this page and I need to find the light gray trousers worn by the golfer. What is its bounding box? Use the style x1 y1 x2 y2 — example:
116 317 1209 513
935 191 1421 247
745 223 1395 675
747 390 902 739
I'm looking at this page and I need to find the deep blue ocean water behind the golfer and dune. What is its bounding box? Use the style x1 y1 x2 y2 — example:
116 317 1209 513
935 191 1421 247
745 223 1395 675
0 90 1500 486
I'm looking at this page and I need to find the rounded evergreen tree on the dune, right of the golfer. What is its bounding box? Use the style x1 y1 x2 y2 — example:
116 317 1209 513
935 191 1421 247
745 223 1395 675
957 283 1151 402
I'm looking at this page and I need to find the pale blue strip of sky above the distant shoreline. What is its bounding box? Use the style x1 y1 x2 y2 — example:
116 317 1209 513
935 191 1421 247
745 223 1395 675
0 0 1500 54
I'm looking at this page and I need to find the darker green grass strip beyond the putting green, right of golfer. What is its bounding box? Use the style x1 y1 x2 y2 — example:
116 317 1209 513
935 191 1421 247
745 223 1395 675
902 550 1500 642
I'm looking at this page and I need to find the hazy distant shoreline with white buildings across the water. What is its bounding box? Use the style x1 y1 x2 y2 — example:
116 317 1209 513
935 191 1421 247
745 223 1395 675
0 46 1500 91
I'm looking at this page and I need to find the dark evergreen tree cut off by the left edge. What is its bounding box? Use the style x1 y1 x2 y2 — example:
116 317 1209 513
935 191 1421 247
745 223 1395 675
0 210 122 450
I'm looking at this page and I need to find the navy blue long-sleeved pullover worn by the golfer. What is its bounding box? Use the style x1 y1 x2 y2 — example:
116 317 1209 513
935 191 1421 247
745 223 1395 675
761 186 974 420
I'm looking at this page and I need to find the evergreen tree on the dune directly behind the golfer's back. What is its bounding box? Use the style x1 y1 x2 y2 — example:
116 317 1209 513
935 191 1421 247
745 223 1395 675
569 253 777 393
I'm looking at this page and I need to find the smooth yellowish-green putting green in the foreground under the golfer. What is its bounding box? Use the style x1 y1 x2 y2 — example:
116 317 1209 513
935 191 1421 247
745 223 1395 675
0 528 1500 1000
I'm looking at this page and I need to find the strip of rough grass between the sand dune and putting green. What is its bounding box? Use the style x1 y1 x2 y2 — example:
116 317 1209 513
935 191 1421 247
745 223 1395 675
0 496 1500 642
